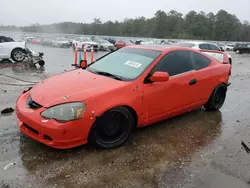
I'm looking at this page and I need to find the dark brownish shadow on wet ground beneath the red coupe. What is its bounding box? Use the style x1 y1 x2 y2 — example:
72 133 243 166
19 109 222 175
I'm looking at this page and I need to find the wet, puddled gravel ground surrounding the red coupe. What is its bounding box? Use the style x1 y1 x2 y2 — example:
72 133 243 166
0 45 250 188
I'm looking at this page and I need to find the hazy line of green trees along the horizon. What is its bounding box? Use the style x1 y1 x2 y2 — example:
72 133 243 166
0 10 250 41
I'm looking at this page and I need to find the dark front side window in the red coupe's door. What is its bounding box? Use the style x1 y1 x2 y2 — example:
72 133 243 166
153 51 194 76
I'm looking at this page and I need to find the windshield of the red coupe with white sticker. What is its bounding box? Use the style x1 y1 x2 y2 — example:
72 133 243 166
87 48 162 80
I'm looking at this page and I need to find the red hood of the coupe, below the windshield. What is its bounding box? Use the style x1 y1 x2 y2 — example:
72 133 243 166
30 69 128 107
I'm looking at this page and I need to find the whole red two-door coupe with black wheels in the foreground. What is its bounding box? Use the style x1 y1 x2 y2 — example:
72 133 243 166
16 45 231 149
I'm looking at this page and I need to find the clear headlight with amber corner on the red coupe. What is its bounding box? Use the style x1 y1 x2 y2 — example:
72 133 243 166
41 102 86 122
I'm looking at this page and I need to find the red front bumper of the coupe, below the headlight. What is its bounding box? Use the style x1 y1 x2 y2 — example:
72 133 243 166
16 92 93 149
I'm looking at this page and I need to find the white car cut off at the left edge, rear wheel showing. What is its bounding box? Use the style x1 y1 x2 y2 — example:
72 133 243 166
0 36 27 62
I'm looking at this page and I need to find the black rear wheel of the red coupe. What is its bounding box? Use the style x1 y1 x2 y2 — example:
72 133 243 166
204 84 227 111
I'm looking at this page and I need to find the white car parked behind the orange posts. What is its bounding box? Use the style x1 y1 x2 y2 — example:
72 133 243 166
72 37 99 52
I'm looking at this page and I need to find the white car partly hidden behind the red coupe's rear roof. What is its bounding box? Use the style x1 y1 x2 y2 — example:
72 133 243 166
177 41 232 65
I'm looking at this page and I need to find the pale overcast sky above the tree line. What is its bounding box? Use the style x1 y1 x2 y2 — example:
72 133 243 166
0 0 250 26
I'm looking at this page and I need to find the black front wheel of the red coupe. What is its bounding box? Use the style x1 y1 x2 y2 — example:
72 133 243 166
88 106 135 149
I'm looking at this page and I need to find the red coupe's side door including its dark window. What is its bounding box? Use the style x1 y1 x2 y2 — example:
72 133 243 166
144 51 197 124
